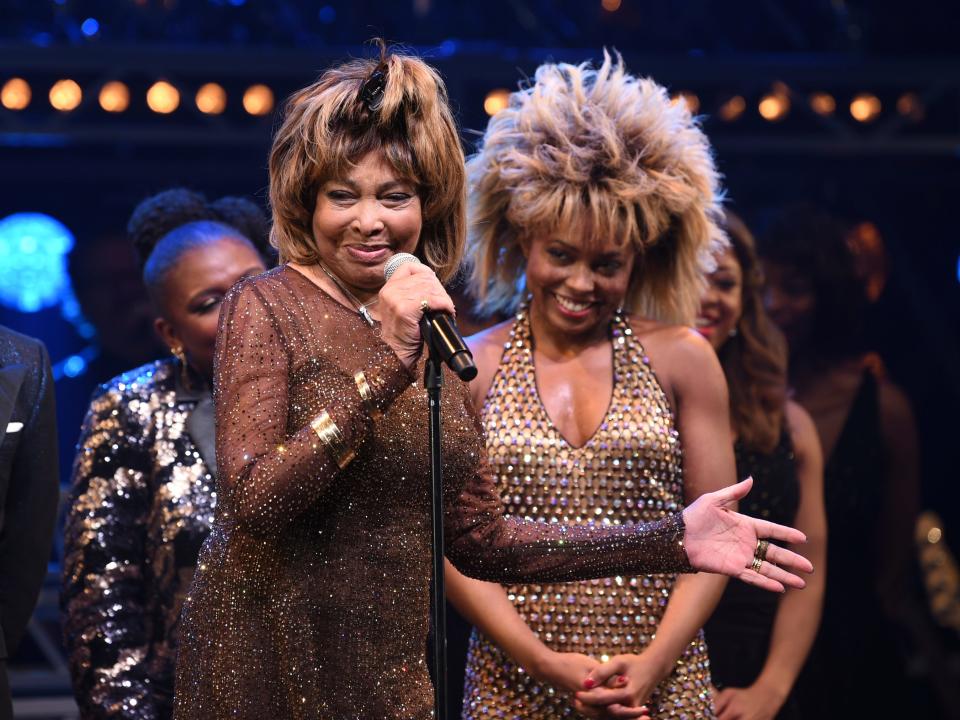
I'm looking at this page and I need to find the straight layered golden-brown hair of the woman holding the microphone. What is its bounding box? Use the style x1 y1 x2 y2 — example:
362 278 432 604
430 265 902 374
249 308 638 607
270 44 466 280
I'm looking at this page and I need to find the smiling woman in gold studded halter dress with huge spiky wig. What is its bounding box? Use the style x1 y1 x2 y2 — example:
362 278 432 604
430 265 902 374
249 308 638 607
447 55 735 720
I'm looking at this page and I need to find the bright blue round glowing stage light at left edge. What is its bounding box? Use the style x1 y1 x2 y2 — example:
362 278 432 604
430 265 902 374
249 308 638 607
0 213 74 312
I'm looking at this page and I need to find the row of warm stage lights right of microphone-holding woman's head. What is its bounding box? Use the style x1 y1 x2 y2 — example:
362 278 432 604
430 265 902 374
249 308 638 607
483 83 924 123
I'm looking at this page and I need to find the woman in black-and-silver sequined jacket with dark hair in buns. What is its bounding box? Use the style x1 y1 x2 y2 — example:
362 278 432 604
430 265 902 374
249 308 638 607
61 190 265 720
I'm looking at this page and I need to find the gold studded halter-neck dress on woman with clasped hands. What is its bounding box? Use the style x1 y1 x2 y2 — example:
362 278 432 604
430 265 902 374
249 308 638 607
463 310 713 720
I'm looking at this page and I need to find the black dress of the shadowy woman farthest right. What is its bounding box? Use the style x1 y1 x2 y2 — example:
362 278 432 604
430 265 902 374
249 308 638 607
798 371 911 720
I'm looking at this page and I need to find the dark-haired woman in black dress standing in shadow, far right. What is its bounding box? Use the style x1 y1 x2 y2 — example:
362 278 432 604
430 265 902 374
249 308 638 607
761 206 919 718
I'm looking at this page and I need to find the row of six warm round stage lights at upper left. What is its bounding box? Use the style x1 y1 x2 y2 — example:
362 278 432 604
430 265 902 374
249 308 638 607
0 78 275 115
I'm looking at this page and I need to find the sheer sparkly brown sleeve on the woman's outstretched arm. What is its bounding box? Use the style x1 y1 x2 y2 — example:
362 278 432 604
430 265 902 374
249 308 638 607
444 381 693 584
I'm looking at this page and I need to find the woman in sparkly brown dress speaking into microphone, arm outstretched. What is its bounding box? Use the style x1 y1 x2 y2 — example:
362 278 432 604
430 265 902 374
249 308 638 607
175 49 809 720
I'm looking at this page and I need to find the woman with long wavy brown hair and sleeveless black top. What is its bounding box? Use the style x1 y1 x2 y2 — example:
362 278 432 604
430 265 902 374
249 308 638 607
697 213 826 720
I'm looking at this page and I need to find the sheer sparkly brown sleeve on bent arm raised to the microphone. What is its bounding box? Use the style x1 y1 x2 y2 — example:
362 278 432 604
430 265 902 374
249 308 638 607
215 281 412 533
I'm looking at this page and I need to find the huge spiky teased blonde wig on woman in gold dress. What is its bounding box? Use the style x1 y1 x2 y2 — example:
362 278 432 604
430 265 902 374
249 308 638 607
467 52 726 325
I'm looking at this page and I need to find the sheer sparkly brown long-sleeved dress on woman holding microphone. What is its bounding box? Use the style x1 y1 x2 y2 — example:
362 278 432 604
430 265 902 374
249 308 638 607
175 267 689 720
